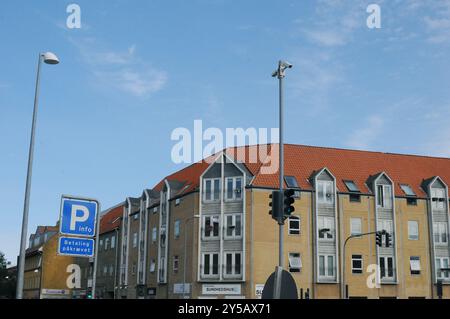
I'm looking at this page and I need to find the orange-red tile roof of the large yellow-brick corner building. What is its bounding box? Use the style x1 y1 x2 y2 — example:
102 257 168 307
149 144 450 197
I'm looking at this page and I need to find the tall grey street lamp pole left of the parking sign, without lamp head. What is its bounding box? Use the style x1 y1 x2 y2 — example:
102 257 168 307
16 53 42 299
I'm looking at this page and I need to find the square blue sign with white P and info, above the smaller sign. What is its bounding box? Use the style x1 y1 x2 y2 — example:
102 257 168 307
60 197 98 237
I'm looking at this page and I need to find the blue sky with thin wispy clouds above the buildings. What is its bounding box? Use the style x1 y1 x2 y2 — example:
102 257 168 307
0 0 450 262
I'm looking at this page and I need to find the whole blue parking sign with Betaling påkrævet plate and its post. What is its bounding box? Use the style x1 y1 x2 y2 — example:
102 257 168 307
57 195 100 299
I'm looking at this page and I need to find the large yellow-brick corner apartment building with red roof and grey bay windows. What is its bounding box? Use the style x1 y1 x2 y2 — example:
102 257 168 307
108 145 450 298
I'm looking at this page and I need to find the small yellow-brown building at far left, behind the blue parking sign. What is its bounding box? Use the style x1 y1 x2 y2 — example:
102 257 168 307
23 224 89 299
